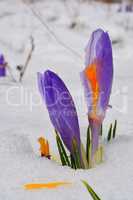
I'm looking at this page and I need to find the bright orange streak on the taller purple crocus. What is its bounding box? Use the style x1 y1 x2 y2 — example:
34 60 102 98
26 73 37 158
85 63 99 115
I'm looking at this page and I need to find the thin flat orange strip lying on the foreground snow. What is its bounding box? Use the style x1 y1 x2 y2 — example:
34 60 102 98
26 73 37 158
24 182 71 190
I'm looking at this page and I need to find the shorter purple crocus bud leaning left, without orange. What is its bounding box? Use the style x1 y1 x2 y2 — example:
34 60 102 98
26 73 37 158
38 70 80 153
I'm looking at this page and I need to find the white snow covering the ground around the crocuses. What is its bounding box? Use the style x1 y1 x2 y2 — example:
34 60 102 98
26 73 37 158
0 0 133 200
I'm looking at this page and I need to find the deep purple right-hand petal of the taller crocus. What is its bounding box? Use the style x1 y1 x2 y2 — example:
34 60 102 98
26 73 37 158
96 30 113 115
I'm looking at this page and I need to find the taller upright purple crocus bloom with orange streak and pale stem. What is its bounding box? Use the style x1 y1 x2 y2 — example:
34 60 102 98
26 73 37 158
81 29 113 156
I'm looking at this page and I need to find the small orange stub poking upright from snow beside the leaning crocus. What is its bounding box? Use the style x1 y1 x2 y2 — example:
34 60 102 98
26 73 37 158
38 137 50 159
